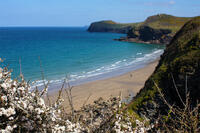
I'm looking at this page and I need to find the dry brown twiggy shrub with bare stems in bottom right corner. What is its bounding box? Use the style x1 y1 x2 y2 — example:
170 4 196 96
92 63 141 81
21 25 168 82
154 79 200 133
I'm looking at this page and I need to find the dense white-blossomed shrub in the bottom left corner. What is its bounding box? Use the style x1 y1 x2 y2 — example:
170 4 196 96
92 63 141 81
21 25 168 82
0 64 81 133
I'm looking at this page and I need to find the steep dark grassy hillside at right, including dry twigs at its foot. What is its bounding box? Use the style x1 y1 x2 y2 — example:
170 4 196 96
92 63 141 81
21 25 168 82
128 17 200 132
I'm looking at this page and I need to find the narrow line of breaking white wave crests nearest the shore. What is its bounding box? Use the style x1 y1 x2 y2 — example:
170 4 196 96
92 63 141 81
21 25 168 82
32 49 163 87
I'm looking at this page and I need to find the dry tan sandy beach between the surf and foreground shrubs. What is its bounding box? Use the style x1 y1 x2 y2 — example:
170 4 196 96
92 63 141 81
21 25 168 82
50 60 158 110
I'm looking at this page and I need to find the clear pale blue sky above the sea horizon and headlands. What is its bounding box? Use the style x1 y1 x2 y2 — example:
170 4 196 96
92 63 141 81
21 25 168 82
0 0 200 26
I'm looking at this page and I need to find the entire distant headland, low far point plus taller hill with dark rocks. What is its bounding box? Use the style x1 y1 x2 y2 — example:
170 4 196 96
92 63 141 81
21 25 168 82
88 14 191 44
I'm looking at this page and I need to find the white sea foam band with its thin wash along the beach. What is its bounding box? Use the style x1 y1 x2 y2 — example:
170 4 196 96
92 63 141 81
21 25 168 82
32 49 163 88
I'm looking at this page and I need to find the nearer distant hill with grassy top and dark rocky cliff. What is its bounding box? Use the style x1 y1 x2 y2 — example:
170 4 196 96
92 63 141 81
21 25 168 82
124 14 191 44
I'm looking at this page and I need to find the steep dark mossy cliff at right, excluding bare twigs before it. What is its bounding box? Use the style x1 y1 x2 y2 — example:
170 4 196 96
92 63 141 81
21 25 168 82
129 17 200 117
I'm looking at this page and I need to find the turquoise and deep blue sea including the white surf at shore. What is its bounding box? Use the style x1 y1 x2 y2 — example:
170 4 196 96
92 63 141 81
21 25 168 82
0 27 164 89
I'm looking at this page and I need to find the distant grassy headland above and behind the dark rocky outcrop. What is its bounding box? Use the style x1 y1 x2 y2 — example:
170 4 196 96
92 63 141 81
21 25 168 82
88 14 190 33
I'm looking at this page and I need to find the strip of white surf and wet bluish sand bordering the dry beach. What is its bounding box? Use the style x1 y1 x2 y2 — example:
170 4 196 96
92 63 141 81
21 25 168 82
39 49 163 93
